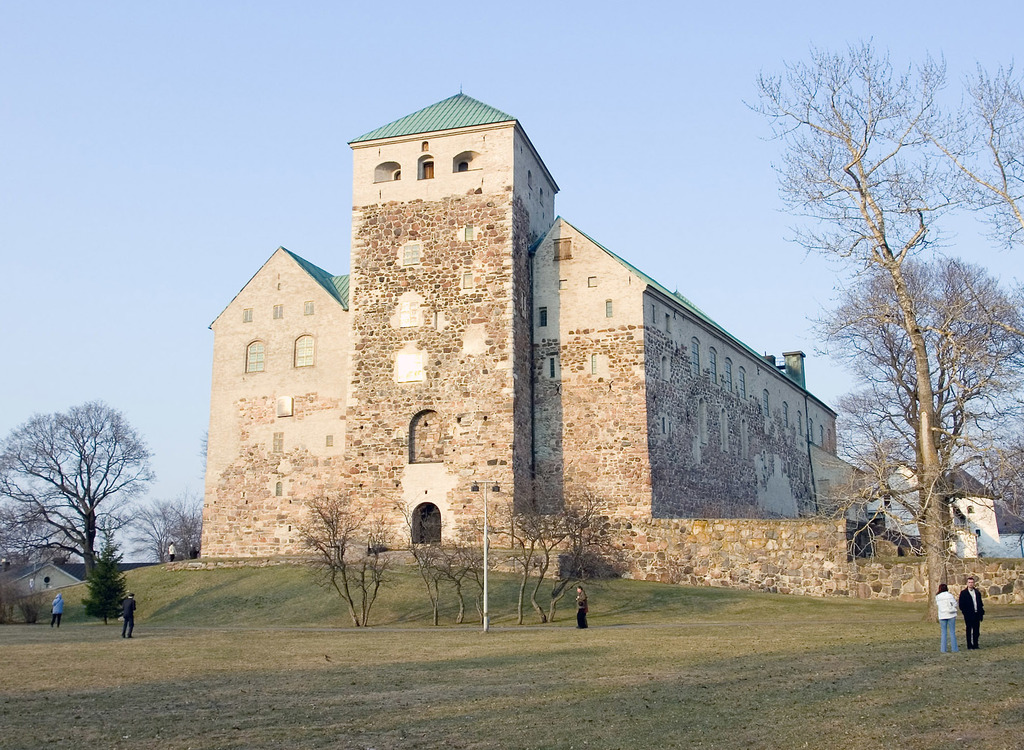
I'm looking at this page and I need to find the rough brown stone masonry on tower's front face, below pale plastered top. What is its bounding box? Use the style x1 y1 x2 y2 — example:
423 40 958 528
345 191 515 538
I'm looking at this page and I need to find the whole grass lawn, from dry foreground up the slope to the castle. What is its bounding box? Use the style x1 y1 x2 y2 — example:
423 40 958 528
0 567 1024 750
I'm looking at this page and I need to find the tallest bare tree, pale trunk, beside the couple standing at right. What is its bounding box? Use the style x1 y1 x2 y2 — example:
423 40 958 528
758 44 1024 618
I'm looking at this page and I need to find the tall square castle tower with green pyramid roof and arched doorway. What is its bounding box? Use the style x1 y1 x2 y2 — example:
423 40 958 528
344 93 558 542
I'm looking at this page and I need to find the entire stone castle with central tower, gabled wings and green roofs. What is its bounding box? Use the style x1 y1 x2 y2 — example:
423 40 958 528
203 93 836 557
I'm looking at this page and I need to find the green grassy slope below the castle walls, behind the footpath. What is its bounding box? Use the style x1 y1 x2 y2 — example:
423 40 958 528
51 565 924 627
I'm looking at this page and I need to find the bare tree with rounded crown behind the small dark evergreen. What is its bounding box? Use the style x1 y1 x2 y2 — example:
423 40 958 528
0 402 154 572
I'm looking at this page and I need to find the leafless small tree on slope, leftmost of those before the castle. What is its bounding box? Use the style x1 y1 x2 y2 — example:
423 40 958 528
299 494 390 627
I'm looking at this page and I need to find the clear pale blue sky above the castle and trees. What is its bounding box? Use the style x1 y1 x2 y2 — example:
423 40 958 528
0 0 1024 504
